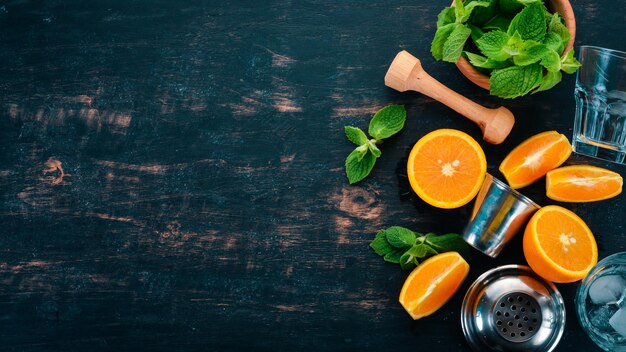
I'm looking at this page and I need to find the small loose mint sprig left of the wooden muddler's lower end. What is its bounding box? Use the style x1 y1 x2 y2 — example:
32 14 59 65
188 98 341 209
344 105 406 184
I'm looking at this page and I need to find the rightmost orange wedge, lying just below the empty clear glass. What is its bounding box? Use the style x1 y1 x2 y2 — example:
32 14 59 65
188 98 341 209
546 165 624 202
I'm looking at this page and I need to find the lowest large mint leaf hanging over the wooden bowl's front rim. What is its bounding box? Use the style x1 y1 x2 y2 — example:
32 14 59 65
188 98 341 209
489 64 542 99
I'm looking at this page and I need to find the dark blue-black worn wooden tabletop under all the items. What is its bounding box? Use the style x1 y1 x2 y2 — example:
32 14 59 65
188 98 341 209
0 0 626 351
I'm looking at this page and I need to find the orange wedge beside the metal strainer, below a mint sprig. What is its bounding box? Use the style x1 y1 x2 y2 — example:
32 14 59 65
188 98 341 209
399 252 469 320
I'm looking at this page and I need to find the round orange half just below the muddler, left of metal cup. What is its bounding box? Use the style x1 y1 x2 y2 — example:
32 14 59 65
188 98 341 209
407 129 487 209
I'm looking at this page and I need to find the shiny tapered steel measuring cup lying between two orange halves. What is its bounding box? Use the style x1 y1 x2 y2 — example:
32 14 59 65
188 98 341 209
463 174 540 258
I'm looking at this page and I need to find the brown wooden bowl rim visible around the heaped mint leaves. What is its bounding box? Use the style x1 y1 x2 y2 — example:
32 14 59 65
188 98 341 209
452 0 576 90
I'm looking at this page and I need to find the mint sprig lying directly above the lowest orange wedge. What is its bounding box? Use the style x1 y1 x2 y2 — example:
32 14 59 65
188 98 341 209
370 226 470 270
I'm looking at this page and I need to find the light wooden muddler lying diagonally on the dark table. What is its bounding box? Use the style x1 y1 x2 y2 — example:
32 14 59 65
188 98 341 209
385 50 515 144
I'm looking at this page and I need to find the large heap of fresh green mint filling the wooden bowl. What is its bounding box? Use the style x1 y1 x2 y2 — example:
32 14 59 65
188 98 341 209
431 0 580 98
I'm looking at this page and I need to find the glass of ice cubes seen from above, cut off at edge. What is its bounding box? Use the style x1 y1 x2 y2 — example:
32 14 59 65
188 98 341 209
576 252 626 352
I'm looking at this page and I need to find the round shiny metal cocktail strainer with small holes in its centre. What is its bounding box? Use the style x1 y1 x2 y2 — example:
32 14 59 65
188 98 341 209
461 265 565 351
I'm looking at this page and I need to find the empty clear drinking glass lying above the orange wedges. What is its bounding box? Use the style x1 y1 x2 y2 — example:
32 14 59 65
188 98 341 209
572 46 626 164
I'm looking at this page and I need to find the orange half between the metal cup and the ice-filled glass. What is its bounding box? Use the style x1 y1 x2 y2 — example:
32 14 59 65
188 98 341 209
524 205 598 282
